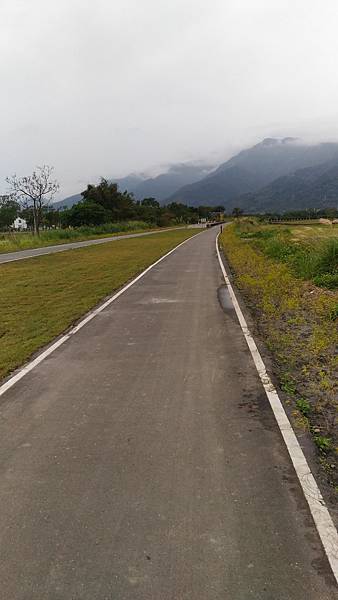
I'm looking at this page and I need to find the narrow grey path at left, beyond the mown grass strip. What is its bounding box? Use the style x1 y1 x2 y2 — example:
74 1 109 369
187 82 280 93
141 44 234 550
0 227 182 264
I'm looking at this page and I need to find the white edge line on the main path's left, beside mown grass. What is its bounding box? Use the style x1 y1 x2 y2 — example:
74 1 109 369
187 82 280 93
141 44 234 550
0 231 204 396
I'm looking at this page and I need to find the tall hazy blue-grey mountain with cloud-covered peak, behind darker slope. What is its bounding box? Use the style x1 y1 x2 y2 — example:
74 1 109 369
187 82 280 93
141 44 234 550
167 138 338 210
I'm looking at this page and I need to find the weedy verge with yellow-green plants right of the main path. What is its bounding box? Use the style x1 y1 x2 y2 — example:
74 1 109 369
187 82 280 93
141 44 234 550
221 221 338 489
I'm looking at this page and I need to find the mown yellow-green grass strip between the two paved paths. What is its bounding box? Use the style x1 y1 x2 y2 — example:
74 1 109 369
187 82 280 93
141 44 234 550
0 229 198 378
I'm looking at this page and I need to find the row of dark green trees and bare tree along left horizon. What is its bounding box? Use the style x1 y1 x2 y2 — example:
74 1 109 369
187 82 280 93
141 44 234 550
0 166 224 235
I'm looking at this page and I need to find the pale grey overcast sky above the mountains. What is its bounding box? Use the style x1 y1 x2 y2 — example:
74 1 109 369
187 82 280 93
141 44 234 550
0 0 338 197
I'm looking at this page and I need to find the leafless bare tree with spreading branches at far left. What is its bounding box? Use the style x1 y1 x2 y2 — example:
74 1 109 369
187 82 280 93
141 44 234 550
6 165 60 235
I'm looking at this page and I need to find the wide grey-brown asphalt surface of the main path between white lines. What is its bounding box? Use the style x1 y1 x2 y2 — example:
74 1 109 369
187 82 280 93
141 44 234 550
0 230 337 600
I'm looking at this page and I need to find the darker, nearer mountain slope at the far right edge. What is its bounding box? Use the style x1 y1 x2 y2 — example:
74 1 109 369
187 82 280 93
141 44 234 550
235 160 338 213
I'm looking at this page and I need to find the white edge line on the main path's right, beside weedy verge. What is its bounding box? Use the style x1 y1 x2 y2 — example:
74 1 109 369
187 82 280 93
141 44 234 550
216 234 338 583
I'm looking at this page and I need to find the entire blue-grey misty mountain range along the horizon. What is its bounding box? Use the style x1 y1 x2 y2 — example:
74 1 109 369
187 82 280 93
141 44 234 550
55 137 338 213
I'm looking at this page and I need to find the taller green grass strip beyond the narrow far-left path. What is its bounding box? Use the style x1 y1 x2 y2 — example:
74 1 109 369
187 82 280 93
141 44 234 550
0 221 181 254
